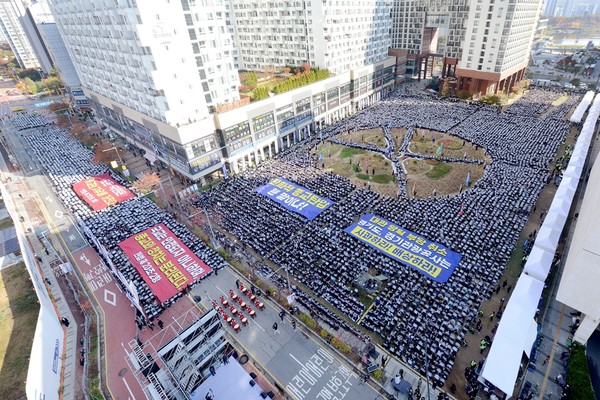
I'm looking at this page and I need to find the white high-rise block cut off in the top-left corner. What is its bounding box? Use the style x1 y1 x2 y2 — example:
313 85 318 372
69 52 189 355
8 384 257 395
0 0 40 69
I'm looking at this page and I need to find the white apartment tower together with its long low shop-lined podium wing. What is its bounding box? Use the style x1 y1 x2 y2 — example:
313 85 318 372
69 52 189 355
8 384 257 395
50 0 397 181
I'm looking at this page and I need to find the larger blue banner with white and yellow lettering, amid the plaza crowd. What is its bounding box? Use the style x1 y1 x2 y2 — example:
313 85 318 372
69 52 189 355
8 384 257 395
345 214 461 283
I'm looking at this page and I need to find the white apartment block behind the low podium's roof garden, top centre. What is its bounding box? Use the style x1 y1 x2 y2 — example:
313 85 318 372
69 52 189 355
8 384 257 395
229 0 392 75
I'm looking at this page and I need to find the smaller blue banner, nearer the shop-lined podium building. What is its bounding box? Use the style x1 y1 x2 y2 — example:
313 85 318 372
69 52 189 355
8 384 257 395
256 178 333 221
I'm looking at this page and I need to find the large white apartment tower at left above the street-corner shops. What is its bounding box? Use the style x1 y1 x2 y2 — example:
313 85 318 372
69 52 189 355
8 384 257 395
49 0 239 177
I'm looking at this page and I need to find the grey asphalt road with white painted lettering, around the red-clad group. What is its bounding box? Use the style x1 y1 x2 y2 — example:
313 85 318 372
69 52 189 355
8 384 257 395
193 269 381 400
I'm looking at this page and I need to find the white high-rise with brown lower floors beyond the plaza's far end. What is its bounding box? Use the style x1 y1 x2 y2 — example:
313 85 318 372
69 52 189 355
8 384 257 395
392 0 542 95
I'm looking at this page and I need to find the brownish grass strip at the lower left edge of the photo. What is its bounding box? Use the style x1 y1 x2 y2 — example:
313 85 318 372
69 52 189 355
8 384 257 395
0 263 40 399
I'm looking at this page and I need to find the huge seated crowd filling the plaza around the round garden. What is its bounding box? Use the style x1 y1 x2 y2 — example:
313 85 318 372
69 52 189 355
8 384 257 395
195 90 574 390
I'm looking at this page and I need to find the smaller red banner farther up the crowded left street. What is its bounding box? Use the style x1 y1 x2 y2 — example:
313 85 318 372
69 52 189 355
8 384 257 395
73 174 135 211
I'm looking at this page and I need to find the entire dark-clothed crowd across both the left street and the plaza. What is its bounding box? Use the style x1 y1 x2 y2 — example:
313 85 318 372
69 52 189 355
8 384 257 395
3 85 578 396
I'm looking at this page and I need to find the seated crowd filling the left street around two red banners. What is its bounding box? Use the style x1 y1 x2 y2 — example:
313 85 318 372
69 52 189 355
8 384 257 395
19 117 224 319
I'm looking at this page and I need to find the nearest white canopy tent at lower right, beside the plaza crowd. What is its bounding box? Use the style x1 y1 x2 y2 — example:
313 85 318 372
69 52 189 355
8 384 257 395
481 274 544 396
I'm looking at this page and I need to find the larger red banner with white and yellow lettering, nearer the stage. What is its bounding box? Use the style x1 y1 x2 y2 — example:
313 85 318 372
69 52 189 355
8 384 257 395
119 224 211 303
